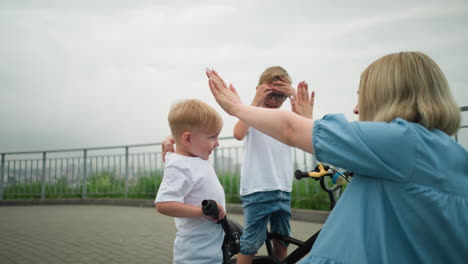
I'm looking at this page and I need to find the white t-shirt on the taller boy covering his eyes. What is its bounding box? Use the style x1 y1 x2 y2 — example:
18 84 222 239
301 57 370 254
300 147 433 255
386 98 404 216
240 127 293 195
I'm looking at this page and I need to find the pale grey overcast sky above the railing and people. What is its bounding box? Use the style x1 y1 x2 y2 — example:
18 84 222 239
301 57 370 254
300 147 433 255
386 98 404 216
0 0 468 152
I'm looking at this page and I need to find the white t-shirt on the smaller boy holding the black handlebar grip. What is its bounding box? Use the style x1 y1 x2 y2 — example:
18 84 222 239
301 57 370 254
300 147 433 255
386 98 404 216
155 152 226 264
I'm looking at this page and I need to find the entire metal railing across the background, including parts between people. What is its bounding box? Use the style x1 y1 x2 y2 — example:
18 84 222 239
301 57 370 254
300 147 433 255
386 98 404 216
0 106 468 202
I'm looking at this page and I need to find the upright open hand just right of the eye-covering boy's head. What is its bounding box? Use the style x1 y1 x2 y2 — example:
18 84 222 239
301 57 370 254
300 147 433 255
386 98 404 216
291 81 315 119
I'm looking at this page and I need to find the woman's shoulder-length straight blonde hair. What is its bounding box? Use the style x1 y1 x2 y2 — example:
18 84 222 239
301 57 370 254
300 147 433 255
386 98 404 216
358 52 461 135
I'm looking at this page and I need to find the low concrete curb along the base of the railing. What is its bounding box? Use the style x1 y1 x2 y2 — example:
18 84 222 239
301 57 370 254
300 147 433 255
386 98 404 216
0 199 330 223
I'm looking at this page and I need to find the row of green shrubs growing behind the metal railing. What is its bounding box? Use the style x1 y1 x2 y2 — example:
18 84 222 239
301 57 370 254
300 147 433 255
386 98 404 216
4 170 344 210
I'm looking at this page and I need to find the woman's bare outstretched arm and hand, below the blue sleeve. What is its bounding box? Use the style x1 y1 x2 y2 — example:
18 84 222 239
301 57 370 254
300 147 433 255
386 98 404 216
207 70 314 153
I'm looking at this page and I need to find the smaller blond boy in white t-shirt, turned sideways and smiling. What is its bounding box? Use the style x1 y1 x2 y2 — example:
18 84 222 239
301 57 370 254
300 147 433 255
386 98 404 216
155 99 225 264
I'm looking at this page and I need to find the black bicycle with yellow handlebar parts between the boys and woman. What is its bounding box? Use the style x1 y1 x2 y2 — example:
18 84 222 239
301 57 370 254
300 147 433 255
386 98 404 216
202 163 353 264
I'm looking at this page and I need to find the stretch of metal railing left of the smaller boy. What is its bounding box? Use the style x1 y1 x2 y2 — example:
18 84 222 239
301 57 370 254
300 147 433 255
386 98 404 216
0 143 163 199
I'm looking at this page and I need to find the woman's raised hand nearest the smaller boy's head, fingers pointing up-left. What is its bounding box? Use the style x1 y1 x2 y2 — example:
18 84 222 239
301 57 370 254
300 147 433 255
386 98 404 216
206 69 242 115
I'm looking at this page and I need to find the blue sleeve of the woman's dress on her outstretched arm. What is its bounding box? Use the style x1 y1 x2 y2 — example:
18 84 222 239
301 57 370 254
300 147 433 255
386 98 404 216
312 114 418 181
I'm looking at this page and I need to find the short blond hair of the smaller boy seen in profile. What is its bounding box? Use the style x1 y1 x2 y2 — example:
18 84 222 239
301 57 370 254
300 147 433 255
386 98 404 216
167 99 223 141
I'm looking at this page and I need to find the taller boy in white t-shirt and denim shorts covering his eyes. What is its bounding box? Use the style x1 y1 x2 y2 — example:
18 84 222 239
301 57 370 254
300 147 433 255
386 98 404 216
234 66 314 263
